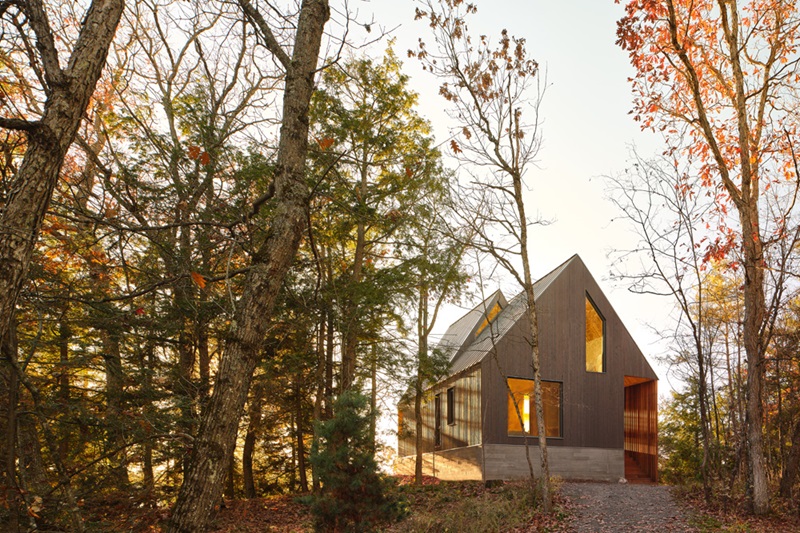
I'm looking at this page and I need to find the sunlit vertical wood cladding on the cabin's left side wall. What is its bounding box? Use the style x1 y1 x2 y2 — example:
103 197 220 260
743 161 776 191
397 367 481 457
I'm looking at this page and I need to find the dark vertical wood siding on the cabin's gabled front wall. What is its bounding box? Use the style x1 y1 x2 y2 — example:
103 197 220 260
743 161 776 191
482 256 657 449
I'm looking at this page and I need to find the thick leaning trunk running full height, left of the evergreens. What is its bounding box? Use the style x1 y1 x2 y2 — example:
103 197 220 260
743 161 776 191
168 0 330 533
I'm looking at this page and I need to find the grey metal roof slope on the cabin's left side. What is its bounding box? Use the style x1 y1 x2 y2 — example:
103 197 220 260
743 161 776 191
438 254 578 376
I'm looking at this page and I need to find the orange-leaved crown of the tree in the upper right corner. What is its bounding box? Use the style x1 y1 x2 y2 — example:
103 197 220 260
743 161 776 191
617 0 800 210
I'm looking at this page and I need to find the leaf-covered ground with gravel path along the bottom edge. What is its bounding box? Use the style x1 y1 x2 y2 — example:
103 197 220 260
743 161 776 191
98 478 800 533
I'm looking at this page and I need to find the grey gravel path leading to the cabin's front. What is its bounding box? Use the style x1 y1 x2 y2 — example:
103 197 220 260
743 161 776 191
561 482 691 533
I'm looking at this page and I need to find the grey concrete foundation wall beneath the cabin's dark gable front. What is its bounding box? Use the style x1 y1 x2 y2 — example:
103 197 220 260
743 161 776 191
484 443 625 481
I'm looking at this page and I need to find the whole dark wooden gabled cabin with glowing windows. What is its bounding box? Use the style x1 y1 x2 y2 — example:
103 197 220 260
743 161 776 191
395 255 658 481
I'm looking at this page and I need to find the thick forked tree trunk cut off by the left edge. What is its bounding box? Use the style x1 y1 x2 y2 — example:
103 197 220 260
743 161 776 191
0 0 125 340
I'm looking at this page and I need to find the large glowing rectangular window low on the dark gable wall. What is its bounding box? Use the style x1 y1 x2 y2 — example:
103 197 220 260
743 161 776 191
508 378 561 437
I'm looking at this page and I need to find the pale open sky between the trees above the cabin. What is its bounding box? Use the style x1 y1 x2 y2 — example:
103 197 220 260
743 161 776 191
350 0 678 395
